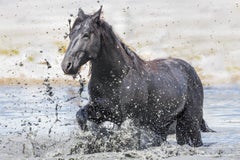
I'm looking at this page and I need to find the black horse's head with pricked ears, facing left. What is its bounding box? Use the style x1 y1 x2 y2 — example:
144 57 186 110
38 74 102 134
62 6 102 74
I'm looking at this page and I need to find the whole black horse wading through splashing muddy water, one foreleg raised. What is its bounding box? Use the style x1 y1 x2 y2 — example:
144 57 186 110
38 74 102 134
62 6 213 147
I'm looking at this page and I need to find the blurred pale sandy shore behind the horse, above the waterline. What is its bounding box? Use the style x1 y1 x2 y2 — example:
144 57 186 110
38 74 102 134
0 0 240 86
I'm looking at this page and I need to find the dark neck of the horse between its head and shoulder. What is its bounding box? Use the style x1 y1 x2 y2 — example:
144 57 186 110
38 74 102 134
91 23 131 79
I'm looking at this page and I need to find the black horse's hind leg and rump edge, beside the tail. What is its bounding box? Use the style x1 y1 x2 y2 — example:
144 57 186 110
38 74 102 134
176 68 203 147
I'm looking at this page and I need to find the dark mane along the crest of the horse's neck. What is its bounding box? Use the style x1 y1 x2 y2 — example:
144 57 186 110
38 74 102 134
101 21 145 71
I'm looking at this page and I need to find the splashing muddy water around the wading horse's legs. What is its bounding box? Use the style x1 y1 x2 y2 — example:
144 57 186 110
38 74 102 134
0 85 240 159
